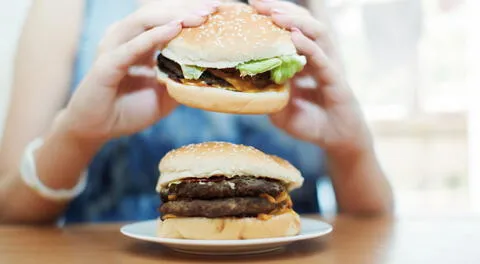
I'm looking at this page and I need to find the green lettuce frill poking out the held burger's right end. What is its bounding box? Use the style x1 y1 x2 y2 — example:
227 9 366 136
271 55 307 84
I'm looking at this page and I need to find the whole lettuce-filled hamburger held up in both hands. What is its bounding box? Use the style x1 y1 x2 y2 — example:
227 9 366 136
157 3 306 114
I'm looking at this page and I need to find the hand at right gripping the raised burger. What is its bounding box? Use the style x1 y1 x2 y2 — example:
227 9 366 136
249 0 372 154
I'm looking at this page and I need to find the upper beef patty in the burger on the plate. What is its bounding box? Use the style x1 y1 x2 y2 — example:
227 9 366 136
160 176 286 202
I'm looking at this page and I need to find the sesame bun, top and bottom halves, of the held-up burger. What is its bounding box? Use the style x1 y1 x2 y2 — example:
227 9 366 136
157 3 297 114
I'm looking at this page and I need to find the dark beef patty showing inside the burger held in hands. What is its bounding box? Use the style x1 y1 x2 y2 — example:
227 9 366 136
157 54 273 89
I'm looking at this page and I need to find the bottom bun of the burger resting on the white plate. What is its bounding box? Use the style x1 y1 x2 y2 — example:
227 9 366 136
157 211 300 240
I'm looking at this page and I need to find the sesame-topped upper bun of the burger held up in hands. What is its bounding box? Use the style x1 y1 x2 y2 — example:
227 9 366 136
162 3 297 69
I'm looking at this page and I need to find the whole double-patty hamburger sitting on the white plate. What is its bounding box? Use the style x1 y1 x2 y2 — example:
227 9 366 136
156 142 303 240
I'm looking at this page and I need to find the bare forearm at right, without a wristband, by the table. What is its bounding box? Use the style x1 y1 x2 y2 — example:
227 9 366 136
327 149 393 215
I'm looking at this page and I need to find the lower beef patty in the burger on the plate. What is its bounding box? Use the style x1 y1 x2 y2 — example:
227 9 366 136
160 197 287 218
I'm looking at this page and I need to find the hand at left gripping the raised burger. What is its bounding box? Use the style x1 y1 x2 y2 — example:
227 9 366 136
57 0 219 141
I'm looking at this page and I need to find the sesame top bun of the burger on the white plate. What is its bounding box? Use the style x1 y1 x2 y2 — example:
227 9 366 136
157 142 303 192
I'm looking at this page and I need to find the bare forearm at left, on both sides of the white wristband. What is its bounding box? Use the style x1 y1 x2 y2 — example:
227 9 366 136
0 110 101 223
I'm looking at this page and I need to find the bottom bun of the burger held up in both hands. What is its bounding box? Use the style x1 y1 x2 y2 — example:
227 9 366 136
157 69 290 114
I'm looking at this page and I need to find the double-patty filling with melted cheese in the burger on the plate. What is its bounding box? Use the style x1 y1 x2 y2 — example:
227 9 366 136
160 176 292 219
